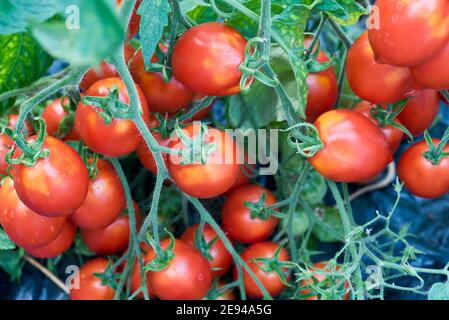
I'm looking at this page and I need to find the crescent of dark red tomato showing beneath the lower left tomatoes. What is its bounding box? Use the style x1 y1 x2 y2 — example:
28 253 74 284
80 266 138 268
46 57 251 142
25 220 76 259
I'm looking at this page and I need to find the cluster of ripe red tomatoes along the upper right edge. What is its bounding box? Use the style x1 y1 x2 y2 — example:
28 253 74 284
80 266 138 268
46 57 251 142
302 0 449 198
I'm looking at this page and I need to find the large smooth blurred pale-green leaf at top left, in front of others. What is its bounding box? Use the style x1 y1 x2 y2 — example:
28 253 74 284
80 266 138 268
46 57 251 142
31 0 125 65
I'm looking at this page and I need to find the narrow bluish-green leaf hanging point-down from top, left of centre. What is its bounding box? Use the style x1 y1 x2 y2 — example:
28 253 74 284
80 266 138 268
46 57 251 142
137 0 170 68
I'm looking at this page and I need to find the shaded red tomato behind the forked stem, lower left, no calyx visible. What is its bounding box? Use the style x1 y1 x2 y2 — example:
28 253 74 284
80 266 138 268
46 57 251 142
81 203 141 255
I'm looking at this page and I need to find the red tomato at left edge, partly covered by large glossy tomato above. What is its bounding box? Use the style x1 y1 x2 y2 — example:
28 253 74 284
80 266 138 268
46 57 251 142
0 178 66 248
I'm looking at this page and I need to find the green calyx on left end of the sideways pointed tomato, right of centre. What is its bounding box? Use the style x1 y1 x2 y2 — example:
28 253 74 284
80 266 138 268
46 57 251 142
281 122 324 158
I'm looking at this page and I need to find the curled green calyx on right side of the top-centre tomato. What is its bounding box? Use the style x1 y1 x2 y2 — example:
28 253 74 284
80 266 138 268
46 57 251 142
239 37 279 92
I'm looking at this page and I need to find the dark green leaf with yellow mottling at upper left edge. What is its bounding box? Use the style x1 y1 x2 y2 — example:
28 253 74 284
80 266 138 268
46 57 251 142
0 32 53 93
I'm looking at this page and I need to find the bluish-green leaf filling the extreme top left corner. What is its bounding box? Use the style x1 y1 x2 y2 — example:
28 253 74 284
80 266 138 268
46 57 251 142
0 0 64 34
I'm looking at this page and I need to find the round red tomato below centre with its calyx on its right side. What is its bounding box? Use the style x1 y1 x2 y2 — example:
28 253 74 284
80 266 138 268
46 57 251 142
221 184 279 243
